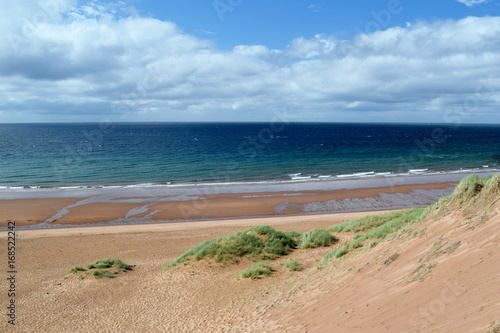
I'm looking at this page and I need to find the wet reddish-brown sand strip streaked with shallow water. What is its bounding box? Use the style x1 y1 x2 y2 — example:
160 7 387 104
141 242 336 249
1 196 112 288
0 183 453 227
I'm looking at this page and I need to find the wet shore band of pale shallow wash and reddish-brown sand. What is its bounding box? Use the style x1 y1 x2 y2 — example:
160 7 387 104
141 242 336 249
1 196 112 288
0 173 496 230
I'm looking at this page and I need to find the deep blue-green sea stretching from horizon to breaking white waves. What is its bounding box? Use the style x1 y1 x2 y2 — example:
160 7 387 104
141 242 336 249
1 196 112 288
0 123 500 189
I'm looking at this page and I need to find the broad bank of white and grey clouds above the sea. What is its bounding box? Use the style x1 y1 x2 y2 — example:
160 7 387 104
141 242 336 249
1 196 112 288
0 0 500 122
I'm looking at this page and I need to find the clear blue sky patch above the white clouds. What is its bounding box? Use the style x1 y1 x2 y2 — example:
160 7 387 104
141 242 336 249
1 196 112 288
137 0 500 49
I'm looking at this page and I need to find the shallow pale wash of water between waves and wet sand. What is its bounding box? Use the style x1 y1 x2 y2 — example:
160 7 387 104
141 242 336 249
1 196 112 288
0 168 500 195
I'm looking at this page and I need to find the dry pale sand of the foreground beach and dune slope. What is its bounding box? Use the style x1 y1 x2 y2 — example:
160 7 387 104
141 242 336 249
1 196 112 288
0 207 500 333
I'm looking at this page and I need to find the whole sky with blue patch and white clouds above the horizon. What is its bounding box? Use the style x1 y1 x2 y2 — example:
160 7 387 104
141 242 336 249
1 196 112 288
0 0 500 124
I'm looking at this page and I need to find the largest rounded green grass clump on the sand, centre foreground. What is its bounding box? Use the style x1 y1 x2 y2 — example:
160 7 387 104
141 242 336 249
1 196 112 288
165 225 299 269
